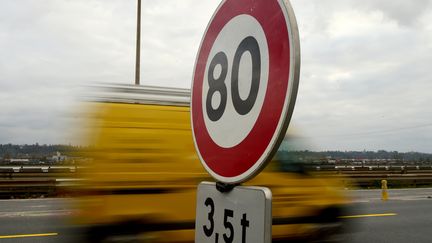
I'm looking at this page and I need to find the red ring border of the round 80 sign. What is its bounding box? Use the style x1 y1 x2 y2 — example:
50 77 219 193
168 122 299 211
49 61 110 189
191 0 292 178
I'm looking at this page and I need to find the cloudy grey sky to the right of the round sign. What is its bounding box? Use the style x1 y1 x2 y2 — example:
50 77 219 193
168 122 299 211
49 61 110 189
293 1 432 151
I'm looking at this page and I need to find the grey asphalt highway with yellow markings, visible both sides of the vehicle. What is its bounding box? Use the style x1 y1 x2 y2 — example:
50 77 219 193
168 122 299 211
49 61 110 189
0 188 432 243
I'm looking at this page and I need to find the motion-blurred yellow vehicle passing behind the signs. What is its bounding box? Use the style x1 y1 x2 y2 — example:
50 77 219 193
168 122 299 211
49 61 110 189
75 85 349 242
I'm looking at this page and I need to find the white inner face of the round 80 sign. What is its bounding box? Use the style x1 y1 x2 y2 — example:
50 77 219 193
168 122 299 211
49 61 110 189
202 14 269 148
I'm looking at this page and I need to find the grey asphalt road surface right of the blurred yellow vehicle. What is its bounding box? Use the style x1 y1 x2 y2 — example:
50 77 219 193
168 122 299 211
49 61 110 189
346 188 432 243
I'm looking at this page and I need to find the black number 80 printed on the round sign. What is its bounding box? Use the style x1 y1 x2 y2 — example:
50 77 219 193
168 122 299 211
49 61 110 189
206 36 261 121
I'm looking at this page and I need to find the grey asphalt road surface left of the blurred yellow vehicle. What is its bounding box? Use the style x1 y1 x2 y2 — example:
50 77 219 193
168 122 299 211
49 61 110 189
0 198 81 243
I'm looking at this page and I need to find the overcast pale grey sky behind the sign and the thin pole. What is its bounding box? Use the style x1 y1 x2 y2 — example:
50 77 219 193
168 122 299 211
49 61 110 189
0 0 432 152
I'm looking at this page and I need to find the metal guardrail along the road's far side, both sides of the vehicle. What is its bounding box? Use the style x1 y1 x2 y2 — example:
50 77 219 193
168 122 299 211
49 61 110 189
0 166 432 198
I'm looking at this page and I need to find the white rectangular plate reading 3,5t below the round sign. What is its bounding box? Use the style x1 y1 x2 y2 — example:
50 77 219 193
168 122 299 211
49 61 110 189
195 182 272 243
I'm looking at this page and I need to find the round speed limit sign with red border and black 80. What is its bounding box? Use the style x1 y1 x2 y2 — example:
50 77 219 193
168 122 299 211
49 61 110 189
191 0 300 183
